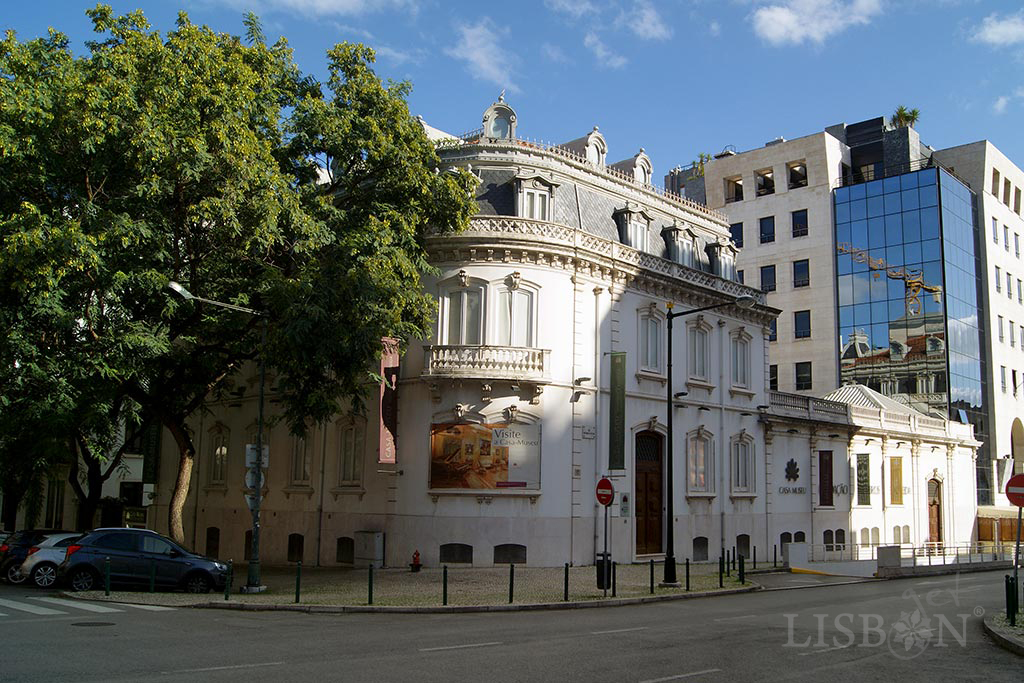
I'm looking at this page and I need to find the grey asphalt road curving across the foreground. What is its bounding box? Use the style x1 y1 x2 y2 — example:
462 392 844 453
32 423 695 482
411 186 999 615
0 572 1024 683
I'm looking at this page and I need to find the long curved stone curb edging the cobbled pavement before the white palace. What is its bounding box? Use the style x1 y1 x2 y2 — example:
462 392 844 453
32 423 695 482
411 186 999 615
157 584 763 614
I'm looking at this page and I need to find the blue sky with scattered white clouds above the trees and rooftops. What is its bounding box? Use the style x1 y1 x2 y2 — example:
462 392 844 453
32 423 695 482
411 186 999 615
6 0 1024 184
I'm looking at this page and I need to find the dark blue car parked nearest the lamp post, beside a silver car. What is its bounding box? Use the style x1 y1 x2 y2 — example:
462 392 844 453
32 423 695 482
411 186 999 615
57 528 227 593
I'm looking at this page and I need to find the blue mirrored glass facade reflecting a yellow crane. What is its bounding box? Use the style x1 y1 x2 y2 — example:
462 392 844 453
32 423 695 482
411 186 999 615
833 167 991 503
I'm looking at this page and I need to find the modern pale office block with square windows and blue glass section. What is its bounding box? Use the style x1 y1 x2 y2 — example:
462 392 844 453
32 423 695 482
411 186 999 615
688 118 1024 538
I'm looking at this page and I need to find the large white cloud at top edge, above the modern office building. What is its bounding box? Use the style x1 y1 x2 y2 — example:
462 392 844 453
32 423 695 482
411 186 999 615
751 0 882 45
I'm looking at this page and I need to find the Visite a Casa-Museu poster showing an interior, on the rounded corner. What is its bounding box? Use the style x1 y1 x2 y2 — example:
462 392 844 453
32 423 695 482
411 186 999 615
430 424 541 490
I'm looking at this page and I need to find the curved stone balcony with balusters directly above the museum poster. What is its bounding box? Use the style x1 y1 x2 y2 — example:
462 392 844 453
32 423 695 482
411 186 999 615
423 345 551 384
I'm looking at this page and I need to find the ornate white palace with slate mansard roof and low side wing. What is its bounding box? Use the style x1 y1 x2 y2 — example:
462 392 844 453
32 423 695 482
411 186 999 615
108 98 978 566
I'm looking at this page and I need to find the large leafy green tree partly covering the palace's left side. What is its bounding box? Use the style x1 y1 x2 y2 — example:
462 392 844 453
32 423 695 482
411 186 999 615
0 5 473 542
